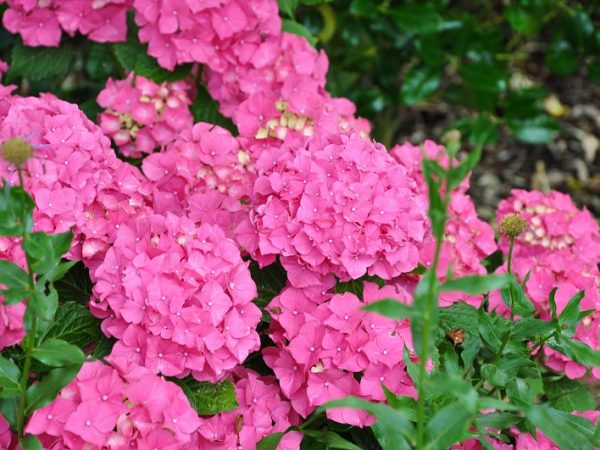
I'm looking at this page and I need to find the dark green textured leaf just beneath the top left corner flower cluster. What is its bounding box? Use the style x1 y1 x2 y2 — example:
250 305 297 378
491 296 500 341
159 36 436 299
7 41 76 80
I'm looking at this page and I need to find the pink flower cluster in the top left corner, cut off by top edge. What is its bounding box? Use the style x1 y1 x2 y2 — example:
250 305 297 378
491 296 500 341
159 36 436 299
2 0 131 47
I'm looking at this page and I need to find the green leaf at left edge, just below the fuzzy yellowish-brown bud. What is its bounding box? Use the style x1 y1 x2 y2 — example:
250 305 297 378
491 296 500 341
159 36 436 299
0 181 35 237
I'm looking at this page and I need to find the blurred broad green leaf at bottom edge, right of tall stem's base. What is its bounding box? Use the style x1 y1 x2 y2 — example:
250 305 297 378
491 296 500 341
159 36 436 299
425 401 475 450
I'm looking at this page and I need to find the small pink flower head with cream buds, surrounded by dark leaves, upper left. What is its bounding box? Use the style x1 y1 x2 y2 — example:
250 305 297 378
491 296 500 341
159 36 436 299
97 72 194 158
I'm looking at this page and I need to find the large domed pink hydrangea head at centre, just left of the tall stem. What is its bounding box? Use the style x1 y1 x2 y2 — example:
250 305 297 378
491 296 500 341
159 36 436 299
241 134 427 287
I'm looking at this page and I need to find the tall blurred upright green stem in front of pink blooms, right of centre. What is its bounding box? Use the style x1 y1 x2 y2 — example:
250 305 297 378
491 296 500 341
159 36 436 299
417 201 449 449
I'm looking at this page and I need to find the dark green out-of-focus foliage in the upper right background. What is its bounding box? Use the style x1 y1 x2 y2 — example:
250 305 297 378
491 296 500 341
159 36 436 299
288 0 600 146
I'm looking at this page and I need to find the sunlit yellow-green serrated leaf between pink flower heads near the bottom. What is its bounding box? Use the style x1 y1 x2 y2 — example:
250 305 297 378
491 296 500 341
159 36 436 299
170 377 239 416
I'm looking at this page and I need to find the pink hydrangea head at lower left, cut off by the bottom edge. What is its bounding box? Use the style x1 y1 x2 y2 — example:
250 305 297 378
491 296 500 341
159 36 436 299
25 361 201 450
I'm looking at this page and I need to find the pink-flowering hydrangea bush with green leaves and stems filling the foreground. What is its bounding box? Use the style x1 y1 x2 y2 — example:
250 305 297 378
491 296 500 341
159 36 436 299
0 0 600 450
